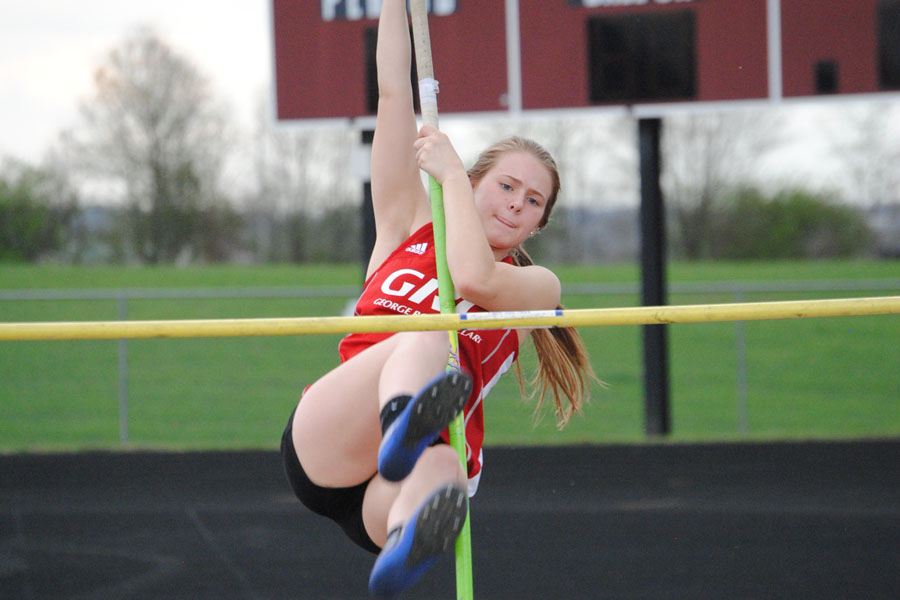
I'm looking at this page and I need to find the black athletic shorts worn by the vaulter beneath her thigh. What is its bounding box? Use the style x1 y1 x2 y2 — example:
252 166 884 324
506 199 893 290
281 413 381 554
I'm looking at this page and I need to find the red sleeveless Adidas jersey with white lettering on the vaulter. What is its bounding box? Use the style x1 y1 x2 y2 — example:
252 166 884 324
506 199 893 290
339 223 519 495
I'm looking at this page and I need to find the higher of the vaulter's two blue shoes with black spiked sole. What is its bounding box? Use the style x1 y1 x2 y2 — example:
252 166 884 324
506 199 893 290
378 371 472 481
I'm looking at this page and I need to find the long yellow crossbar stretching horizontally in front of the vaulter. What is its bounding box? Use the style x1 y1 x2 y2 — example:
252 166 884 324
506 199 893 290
0 296 900 341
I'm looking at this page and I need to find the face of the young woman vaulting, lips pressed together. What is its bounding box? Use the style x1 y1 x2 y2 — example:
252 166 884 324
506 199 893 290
475 152 553 258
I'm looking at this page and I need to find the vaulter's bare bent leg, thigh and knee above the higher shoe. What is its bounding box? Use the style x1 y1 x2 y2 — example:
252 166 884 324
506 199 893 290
292 331 449 487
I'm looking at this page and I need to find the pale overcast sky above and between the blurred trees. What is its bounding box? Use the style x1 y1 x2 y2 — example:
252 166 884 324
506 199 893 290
0 0 900 205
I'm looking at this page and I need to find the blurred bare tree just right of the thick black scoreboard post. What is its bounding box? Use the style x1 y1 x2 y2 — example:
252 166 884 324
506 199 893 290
662 110 782 259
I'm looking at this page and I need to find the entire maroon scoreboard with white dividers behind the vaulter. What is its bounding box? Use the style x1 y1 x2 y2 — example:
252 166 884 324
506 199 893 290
272 0 900 120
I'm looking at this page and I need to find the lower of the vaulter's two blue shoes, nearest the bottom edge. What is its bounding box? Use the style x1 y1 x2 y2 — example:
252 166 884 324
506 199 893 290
369 485 468 598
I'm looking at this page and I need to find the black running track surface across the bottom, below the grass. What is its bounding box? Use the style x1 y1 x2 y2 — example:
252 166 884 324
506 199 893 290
0 440 900 600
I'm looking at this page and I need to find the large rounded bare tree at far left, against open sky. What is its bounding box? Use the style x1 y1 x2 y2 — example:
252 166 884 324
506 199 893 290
64 29 229 263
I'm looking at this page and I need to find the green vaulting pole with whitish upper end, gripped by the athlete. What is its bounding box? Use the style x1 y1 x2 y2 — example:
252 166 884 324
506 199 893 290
410 0 473 600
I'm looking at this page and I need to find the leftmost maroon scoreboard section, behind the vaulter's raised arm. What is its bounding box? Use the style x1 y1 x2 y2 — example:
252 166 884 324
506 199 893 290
272 0 507 119
